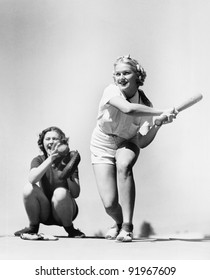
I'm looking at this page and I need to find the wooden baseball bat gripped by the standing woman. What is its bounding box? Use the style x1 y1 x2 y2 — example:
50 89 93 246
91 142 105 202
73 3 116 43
155 93 203 126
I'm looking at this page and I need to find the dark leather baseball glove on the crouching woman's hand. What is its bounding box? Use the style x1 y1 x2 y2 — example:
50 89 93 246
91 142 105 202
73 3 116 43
59 150 81 180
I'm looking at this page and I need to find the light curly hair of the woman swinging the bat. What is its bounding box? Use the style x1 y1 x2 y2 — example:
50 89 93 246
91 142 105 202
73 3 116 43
113 55 147 86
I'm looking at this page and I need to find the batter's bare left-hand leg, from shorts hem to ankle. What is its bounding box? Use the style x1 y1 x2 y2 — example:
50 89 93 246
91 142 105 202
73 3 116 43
93 164 123 224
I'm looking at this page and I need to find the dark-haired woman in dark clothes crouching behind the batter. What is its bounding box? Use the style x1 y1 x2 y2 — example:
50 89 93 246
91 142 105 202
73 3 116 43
15 127 85 237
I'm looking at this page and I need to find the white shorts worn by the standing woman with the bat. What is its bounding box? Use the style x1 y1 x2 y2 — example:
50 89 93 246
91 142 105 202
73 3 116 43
90 127 138 165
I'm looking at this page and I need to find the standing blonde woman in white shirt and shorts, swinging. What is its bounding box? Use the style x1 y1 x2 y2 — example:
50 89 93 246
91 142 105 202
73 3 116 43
90 56 178 242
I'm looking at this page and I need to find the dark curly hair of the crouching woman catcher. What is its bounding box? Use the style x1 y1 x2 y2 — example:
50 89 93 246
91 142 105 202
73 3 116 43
37 126 69 157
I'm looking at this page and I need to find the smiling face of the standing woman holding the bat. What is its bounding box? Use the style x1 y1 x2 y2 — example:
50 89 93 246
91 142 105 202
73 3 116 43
114 62 138 97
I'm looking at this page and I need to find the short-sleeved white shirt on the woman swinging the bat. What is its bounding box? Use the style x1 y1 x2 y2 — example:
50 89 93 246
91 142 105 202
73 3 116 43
97 84 153 139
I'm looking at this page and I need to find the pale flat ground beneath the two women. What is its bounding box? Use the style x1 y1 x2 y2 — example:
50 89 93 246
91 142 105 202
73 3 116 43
0 236 210 260
